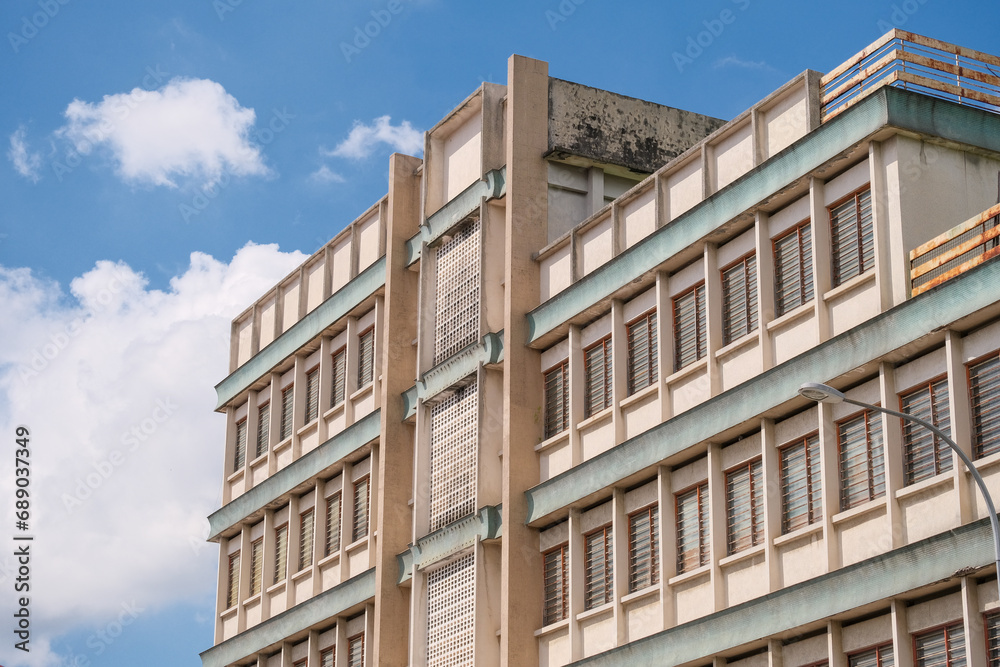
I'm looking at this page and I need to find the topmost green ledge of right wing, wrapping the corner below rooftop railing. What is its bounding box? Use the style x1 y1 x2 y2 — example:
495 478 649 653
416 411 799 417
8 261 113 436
527 88 1000 345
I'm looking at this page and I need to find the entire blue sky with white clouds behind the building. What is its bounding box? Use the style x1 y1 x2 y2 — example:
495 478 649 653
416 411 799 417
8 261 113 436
0 0 1000 667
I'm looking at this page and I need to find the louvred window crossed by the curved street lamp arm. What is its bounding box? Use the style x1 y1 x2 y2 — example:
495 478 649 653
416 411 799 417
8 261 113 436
899 378 951 484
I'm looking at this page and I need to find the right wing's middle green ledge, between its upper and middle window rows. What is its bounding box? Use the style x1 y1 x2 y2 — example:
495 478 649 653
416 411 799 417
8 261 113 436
525 261 1000 523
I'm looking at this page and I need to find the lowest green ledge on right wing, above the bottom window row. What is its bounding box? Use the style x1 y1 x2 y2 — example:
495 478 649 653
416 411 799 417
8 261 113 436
572 519 993 667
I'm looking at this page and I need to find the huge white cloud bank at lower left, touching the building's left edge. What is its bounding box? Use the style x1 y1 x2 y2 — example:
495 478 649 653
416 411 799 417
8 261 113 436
0 244 305 667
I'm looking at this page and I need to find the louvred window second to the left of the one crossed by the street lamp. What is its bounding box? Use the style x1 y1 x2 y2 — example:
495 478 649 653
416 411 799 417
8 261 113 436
781 435 823 533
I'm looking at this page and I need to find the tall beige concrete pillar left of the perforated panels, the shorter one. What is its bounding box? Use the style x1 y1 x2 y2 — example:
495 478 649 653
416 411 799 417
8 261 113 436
374 153 420 666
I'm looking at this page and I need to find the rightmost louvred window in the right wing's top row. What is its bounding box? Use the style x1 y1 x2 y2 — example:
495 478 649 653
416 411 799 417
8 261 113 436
830 189 875 287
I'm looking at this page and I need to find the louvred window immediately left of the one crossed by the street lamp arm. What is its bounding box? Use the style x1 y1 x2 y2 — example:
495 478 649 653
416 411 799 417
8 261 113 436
837 410 885 510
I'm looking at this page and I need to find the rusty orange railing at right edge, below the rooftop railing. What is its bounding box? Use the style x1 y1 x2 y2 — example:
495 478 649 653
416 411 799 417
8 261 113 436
910 204 1000 296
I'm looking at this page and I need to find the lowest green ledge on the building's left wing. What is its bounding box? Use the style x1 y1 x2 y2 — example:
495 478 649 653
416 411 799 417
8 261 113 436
201 568 375 667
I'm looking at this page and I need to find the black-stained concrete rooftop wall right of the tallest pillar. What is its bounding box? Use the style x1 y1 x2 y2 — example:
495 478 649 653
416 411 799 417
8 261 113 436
548 78 726 174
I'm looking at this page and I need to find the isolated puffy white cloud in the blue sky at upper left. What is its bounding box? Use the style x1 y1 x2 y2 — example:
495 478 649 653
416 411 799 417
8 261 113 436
57 78 269 187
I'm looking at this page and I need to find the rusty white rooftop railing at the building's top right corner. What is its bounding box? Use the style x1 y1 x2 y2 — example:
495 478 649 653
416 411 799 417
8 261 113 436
820 30 1000 122
